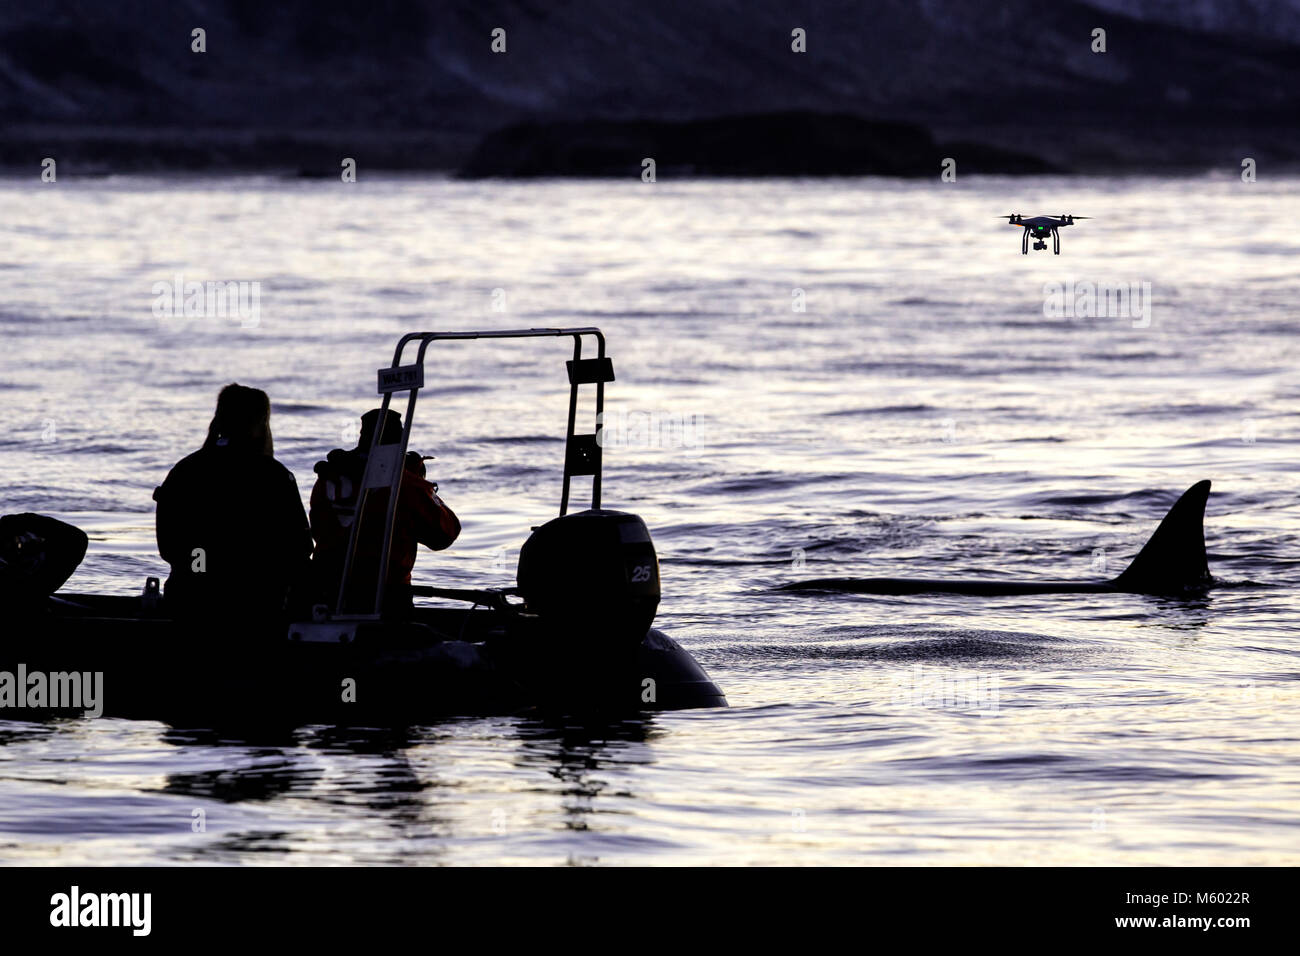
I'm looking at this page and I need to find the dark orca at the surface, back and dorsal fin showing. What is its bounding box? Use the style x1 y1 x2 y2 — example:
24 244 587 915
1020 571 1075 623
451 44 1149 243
777 481 1214 596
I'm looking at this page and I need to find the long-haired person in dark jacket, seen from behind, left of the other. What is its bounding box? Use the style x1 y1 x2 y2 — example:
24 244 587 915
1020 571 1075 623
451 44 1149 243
153 384 312 619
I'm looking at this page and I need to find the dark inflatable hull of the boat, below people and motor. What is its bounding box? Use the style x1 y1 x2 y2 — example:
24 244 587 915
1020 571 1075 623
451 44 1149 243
0 594 727 726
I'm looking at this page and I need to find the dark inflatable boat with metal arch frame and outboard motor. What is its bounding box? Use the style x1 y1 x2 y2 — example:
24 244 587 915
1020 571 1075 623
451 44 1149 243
0 328 727 726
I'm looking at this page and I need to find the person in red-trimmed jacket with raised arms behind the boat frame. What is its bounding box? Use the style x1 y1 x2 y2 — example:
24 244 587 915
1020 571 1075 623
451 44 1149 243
311 408 460 617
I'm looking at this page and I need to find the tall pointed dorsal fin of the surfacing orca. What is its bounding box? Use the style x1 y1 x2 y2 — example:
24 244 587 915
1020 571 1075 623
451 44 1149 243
1113 480 1214 594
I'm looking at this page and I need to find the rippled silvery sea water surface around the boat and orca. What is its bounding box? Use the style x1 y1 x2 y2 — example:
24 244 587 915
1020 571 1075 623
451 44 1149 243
0 177 1300 865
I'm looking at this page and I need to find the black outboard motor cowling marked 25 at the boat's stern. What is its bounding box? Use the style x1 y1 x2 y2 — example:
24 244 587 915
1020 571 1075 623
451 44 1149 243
517 510 659 646
